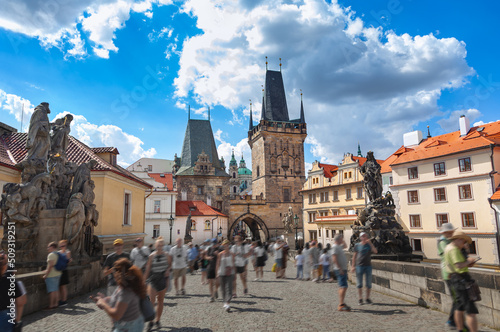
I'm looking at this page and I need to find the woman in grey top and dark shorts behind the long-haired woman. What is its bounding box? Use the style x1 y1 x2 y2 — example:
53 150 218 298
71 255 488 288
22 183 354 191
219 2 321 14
144 237 172 331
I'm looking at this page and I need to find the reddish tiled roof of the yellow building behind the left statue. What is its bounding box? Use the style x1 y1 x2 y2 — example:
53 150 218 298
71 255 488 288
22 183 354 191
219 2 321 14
0 133 152 188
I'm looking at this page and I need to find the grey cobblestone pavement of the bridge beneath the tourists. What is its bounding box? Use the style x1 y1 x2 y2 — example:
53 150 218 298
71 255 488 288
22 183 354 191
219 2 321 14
24 264 494 332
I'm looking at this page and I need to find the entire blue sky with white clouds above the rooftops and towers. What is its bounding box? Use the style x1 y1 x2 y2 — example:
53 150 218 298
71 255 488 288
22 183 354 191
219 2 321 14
0 0 500 170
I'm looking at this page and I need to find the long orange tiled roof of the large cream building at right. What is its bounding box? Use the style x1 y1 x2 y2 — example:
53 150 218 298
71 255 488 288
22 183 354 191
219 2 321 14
391 121 500 166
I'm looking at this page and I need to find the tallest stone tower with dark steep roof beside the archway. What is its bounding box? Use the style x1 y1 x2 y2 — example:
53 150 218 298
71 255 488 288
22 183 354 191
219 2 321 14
248 70 307 204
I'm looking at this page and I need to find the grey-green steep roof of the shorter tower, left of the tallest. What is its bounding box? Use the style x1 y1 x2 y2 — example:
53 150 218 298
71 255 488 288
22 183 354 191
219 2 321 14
177 119 222 175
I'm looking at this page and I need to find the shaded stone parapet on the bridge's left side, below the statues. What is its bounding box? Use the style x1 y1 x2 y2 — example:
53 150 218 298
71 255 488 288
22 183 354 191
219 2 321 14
16 259 105 315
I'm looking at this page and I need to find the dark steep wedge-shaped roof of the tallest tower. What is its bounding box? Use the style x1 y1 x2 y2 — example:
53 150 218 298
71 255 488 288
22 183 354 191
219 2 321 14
262 70 290 121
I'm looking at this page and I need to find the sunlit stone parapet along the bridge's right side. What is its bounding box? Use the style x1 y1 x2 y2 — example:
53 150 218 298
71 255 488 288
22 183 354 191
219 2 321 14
350 260 500 329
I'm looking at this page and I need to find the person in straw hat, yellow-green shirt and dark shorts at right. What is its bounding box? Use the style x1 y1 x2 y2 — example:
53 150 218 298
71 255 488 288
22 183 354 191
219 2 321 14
444 231 479 332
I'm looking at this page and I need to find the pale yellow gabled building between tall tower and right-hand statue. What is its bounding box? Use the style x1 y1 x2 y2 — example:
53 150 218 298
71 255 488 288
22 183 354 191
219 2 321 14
301 153 376 244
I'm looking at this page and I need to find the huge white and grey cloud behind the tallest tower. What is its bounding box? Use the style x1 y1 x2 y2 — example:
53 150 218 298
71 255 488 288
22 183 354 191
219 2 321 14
174 0 474 163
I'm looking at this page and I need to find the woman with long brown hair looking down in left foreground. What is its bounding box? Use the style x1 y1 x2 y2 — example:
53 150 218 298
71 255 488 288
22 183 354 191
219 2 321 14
93 258 146 332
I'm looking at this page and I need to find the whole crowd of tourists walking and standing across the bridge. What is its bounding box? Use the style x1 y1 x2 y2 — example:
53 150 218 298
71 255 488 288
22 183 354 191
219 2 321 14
0 227 478 332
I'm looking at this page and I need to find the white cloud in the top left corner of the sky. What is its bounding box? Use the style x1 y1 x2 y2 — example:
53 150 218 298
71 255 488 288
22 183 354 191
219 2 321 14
0 0 172 58
